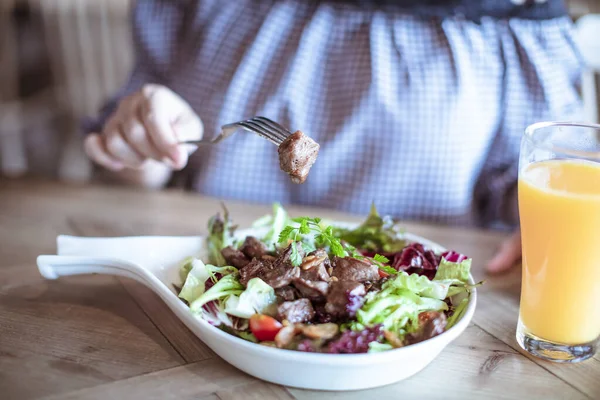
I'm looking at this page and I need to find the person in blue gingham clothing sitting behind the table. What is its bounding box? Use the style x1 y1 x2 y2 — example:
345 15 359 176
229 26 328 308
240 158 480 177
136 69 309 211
85 0 581 272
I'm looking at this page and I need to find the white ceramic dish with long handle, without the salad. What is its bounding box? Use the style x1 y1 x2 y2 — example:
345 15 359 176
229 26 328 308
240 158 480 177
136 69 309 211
37 230 477 390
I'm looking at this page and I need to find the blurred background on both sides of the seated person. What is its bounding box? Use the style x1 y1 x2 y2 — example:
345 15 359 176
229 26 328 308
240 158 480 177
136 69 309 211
0 0 600 182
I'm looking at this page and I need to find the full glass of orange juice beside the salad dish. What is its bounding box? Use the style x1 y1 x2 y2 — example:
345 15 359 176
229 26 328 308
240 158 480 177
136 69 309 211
517 122 600 362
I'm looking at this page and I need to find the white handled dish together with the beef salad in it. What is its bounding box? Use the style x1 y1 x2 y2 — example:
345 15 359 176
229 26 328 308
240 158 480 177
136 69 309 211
37 205 477 390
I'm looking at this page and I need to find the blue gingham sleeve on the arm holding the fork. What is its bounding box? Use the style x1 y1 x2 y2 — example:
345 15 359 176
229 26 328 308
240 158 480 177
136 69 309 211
83 0 186 133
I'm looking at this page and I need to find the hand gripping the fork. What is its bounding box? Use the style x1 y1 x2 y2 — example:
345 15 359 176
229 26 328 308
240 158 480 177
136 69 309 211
84 84 204 171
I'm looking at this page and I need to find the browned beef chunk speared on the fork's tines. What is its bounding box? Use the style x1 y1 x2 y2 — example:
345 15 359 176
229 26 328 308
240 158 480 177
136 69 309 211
277 131 320 183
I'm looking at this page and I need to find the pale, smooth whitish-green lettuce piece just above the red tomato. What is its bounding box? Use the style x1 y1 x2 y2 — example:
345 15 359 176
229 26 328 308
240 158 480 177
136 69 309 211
225 278 277 318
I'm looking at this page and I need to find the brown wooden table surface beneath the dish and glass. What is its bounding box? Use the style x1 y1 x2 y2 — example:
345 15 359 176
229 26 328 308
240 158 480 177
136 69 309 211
0 180 600 400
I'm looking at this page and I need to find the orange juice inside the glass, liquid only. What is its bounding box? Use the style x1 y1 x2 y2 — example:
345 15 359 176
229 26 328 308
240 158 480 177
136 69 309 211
519 160 600 344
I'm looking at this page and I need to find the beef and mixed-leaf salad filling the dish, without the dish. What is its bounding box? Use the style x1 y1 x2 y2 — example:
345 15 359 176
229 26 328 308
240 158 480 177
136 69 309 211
177 204 476 354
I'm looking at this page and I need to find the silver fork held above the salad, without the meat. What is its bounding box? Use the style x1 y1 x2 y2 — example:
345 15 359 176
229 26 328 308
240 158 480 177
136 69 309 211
179 117 292 146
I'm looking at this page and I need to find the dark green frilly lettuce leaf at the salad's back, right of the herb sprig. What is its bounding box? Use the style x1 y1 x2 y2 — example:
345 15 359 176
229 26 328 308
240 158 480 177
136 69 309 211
334 205 406 253
